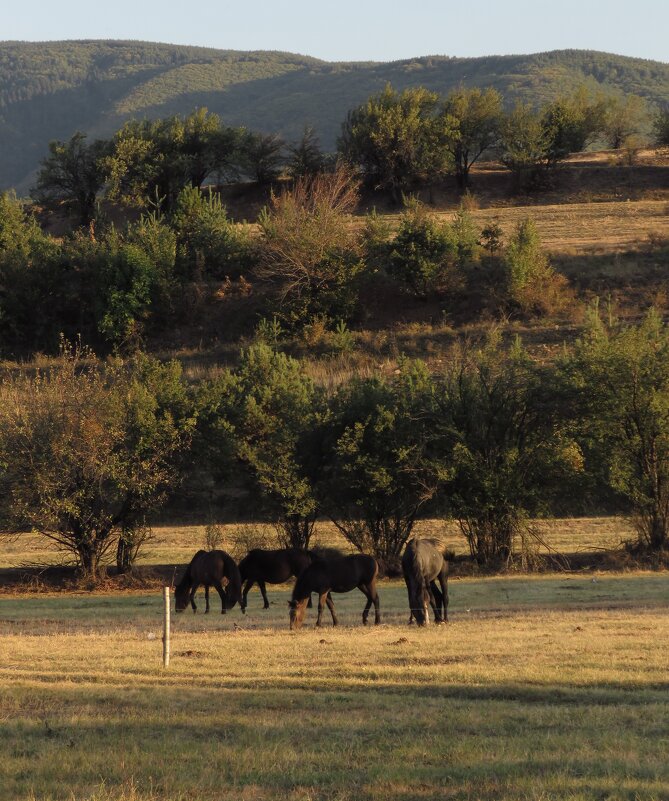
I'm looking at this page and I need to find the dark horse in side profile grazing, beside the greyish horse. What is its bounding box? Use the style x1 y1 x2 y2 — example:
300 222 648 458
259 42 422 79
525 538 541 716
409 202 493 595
289 554 381 629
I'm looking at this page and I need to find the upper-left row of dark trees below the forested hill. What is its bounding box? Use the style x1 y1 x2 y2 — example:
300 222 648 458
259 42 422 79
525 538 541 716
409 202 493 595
32 108 325 226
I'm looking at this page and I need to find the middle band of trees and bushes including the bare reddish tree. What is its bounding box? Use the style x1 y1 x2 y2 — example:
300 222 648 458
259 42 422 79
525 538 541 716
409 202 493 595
0 176 568 355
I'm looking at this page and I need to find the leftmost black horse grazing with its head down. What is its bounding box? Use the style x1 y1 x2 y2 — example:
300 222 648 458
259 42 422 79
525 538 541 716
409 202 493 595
174 551 242 614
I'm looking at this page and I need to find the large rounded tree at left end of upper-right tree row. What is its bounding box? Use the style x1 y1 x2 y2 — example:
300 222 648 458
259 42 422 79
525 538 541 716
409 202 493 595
337 85 445 202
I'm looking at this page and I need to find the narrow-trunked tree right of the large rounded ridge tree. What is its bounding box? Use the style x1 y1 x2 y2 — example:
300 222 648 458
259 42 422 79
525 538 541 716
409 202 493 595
441 88 502 191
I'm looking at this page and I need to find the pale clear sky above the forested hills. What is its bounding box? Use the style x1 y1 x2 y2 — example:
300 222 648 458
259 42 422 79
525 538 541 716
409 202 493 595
0 0 669 62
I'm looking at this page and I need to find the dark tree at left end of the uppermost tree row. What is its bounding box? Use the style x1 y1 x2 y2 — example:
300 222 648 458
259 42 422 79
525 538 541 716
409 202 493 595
32 132 109 226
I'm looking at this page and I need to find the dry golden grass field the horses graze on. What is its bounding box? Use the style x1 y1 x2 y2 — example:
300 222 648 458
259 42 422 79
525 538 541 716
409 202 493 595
0 519 669 801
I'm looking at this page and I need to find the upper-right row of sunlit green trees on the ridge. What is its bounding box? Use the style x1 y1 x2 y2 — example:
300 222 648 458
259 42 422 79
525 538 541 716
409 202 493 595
339 86 666 197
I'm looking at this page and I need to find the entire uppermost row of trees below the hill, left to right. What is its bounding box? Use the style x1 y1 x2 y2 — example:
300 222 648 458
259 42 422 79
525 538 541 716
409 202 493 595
33 86 667 226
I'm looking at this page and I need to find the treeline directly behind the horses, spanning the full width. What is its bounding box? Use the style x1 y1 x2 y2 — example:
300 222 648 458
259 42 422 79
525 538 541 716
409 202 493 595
0 307 669 576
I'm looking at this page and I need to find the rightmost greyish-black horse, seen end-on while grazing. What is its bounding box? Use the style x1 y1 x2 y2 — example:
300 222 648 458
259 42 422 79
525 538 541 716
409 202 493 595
402 539 448 626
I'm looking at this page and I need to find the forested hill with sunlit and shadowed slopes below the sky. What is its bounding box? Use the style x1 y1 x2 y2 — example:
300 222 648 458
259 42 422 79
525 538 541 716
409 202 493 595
0 41 669 191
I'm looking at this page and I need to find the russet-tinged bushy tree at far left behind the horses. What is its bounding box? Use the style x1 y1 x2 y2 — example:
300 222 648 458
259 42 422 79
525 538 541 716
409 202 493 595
0 346 193 579
